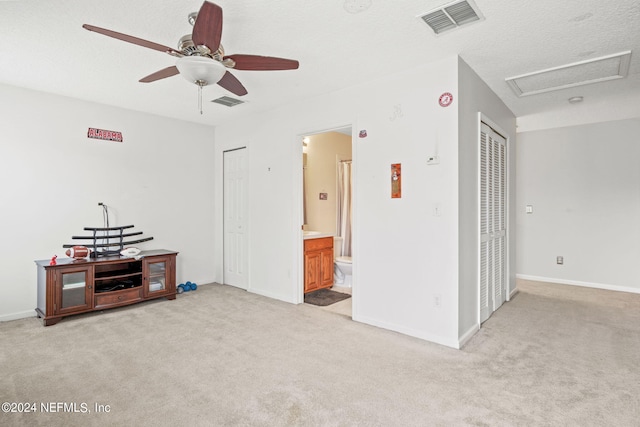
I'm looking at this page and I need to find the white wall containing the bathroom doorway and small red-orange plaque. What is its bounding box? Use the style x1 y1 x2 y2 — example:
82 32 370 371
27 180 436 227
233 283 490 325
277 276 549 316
216 57 513 347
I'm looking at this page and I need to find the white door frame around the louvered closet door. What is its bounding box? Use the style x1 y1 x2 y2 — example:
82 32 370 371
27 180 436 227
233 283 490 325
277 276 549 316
476 112 513 327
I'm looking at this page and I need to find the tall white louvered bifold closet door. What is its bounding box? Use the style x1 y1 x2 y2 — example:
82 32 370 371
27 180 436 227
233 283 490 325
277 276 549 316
480 123 507 322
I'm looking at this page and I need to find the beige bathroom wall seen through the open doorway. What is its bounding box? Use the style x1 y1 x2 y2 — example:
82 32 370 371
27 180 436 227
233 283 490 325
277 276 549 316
305 132 351 235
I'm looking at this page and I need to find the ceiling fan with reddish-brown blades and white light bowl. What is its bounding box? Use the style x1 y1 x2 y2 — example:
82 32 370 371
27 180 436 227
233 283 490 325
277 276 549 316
82 1 299 99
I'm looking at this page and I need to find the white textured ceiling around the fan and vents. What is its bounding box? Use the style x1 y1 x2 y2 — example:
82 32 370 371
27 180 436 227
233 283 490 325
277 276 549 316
0 0 640 125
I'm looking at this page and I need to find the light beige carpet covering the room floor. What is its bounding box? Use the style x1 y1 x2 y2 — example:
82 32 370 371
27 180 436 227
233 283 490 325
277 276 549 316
0 282 640 426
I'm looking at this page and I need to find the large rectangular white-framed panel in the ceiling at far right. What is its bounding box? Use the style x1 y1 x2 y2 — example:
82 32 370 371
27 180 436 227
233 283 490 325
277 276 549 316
506 51 631 96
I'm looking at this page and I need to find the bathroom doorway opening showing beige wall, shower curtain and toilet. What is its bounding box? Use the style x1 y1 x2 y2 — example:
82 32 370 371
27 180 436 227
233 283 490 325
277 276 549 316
301 126 353 317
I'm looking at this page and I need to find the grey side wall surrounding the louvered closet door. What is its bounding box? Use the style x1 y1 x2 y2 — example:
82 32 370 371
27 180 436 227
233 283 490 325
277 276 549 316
458 59 517 341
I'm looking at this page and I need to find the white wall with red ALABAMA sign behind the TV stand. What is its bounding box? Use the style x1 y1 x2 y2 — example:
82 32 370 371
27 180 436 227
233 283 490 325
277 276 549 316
0 85 214 320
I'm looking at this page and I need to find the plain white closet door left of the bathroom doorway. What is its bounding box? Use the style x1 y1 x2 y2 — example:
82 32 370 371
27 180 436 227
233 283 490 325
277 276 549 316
223 148 248 289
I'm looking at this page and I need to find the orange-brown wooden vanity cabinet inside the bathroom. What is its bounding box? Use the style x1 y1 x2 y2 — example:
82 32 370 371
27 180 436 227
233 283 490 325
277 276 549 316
304 237 333 293
